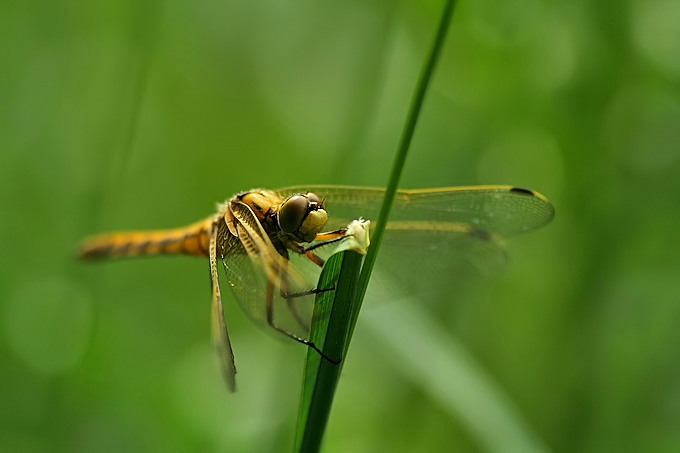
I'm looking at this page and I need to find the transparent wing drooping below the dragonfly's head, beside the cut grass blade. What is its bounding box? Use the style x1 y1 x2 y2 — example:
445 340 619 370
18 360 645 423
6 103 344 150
223 203 314 338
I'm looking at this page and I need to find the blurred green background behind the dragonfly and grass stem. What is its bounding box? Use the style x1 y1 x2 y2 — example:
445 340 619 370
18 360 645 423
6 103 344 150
0 0 680 452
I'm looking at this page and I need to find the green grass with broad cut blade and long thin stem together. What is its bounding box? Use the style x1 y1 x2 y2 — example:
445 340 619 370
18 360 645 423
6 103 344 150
295 0 455 452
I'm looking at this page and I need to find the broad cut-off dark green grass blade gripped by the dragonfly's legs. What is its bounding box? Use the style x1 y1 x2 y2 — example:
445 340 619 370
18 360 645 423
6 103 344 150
294 251 363 452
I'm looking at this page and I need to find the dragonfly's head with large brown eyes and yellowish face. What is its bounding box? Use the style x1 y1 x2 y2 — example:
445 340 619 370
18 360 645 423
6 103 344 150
278 192 328 242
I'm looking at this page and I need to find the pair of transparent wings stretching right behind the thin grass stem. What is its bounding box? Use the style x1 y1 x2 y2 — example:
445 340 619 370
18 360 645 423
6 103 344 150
280 186 554 300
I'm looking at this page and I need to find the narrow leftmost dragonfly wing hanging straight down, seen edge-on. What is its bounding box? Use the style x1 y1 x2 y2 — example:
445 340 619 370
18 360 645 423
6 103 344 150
209 224 236 392
